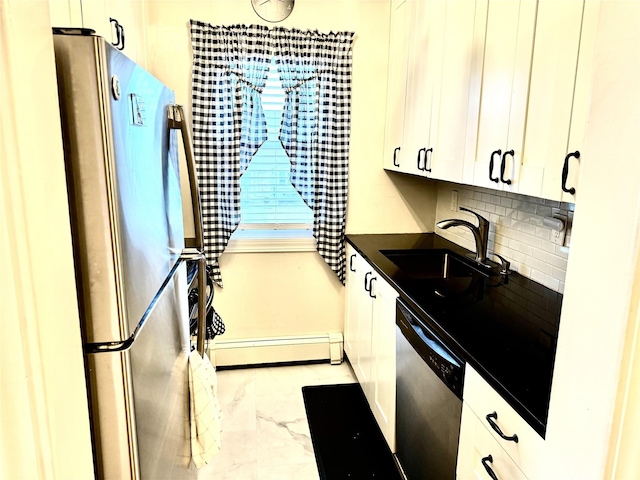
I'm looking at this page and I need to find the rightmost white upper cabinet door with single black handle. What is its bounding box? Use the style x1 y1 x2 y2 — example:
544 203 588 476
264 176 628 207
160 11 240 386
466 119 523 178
518 0 599 202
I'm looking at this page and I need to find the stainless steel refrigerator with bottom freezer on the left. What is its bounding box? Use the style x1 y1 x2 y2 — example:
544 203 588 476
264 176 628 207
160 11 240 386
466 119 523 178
54 30 204 480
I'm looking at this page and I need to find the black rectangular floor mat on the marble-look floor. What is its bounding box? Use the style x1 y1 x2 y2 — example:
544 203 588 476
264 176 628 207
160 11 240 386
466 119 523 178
302 383 401 480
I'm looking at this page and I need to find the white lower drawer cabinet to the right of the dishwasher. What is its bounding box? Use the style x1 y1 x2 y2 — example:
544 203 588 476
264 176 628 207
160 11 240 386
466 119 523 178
458 364 550 480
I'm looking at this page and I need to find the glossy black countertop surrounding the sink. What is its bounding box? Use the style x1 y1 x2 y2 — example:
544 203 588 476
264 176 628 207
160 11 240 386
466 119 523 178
347 233 562 437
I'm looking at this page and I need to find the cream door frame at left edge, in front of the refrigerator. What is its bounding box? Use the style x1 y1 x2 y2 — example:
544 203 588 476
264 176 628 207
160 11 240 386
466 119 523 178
0 0 93 480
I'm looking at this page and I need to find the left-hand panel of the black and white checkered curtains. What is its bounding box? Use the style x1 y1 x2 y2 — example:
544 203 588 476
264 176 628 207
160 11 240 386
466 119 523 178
191 20 271 286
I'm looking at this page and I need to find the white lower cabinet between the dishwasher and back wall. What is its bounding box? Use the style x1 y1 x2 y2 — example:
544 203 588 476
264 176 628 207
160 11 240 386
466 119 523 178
344 244 398 450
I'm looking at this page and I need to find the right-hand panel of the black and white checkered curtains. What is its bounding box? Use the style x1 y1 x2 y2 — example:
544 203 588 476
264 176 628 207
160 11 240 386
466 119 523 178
271 28 354 283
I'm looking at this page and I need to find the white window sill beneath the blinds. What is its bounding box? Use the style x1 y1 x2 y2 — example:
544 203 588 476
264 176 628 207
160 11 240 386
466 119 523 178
224 230 316 253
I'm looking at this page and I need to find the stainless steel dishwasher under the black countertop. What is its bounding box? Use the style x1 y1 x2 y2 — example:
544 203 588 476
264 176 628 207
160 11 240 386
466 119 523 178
396 299 464 480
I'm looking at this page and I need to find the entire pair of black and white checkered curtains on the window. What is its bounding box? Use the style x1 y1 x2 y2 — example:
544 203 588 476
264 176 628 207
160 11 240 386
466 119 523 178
191 20 354 286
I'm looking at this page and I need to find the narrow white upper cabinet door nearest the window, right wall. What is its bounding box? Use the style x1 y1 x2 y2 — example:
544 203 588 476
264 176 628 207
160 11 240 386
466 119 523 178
383 0 411 172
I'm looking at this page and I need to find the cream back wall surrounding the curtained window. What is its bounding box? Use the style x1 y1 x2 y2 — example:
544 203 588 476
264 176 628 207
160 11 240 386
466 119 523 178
145 0 435 352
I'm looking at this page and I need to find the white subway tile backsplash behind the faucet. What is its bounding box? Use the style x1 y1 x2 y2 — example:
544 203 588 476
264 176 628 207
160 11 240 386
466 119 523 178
435 182 574 293
